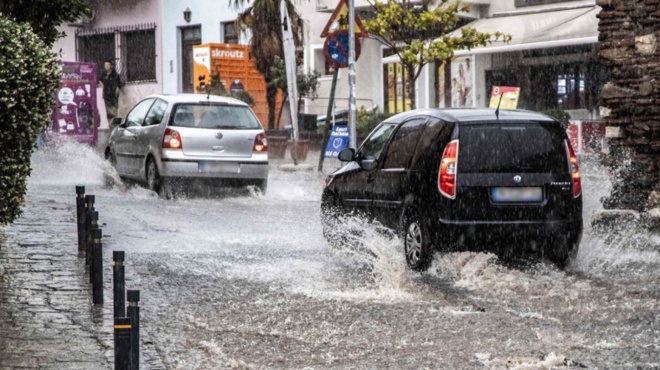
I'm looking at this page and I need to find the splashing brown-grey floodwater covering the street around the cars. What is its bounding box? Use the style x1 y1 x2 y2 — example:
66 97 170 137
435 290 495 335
28 144 660 369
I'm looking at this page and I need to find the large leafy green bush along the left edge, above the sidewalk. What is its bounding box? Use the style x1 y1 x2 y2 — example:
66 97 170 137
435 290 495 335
0 16 60 224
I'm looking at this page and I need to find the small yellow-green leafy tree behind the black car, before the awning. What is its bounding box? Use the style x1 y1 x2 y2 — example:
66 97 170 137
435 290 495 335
364 0 511 109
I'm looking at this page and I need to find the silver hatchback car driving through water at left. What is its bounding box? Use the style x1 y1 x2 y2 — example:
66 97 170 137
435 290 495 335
105 94 268 196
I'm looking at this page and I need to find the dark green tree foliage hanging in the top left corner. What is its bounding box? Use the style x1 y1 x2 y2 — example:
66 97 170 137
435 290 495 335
0 0 92 46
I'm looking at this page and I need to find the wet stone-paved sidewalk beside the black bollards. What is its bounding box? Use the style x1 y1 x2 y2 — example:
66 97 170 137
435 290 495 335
0 194 164 369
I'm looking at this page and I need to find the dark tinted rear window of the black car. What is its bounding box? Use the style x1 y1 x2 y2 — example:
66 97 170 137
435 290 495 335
458 122 568 173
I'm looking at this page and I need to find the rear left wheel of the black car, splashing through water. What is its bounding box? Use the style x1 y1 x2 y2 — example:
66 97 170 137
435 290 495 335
403 215 433 271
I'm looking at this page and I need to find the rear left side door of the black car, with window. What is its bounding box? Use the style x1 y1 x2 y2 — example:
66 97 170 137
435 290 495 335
371 117 427 228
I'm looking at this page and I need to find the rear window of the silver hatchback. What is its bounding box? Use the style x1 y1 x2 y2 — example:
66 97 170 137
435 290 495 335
170 103 262 130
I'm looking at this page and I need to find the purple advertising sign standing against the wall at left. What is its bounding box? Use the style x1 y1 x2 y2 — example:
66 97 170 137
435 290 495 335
49 62 100 144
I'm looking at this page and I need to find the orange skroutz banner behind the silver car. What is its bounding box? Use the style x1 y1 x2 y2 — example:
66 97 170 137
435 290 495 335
193 44 282 127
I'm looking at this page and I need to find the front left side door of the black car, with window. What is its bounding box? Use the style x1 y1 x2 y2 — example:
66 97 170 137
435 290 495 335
339 123 397 214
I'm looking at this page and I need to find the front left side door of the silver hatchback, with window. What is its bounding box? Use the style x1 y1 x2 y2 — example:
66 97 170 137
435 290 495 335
114 99 154 177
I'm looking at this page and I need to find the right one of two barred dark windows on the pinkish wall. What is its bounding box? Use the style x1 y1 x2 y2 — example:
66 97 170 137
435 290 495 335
122 29 156 82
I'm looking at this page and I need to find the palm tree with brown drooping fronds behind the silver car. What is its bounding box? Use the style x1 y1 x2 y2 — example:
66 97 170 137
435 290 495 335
230 0 303 129
